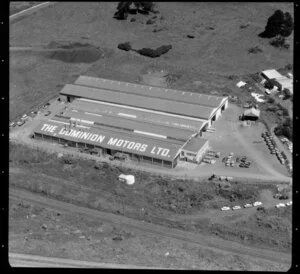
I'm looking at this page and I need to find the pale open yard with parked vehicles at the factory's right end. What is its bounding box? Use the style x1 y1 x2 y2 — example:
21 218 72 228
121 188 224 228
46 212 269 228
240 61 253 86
197 104 289 177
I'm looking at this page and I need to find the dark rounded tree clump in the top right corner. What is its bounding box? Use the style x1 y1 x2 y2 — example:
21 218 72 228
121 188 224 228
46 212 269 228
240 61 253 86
259 10 294 38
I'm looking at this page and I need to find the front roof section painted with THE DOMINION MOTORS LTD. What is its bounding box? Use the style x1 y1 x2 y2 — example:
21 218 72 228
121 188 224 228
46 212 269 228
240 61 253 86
34 120 182 161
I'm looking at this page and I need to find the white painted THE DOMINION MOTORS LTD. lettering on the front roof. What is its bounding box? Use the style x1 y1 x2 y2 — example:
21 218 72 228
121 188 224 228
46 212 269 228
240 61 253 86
41 124 170 157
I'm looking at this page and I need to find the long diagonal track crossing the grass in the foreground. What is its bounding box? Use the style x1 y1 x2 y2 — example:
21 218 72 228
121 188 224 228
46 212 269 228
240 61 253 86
9 188 291 264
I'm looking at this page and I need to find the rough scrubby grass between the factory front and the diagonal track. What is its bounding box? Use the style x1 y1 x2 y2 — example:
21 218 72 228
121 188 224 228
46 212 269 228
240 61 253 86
10 144 291 254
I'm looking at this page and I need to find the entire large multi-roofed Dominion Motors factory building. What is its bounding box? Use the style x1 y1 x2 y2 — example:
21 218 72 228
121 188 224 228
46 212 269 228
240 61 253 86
34 76 228 168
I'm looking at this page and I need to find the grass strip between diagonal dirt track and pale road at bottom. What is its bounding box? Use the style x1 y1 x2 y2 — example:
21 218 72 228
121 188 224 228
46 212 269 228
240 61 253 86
9 197 286 271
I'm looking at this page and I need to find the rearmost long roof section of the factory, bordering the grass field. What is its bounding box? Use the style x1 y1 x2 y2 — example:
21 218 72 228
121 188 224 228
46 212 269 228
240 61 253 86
75 76 224 108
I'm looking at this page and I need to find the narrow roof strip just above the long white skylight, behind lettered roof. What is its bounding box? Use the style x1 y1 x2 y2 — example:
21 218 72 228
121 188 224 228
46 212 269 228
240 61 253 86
64 110 192 141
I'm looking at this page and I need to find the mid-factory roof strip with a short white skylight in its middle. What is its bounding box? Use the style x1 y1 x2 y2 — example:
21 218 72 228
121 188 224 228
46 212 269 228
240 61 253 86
71 99 207 132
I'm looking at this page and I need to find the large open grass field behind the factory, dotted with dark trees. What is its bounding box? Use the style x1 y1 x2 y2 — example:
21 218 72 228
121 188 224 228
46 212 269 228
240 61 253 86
10 2 293 119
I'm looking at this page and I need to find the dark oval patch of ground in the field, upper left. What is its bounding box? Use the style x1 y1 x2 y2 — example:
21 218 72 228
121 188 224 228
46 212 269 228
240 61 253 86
44 42 103 63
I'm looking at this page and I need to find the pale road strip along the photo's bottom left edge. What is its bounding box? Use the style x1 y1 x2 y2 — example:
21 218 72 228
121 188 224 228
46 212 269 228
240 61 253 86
9 253 164 269
